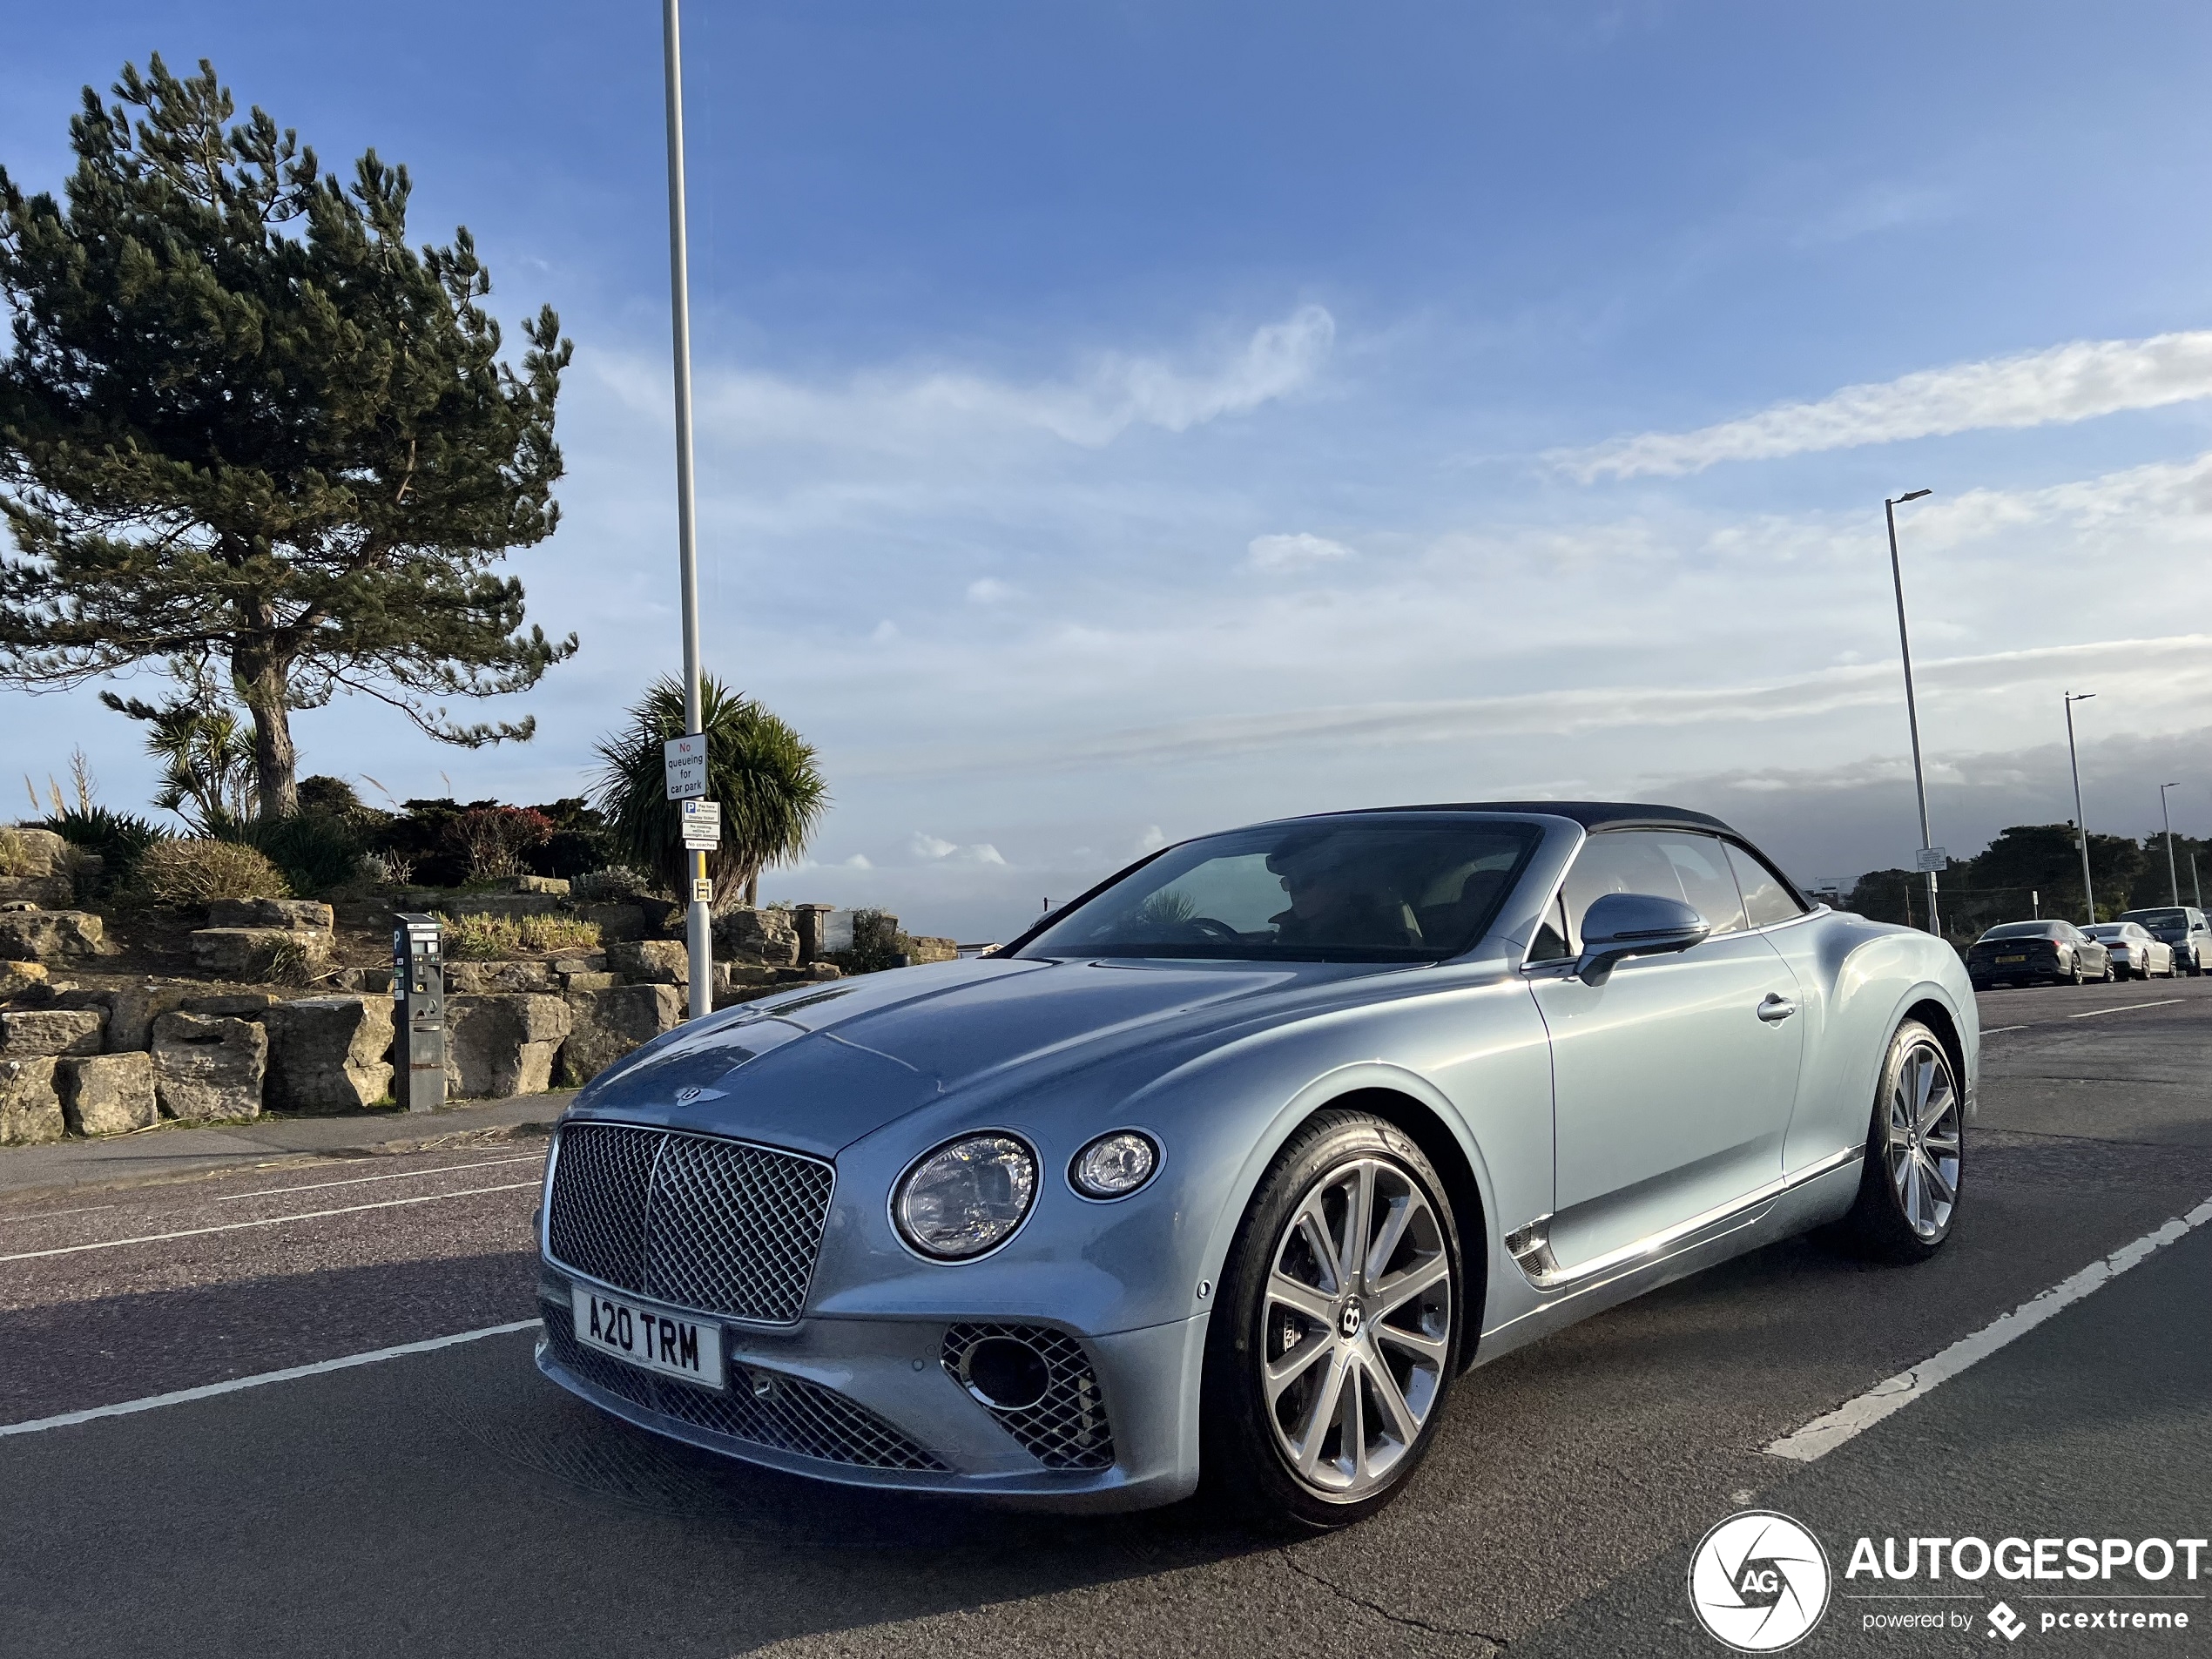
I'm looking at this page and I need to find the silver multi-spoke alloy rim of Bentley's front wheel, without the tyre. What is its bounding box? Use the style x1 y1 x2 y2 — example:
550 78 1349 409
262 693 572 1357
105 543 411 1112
1258 1157 1451 1502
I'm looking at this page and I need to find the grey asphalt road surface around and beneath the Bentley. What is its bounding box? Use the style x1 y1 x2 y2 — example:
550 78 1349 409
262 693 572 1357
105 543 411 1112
0 980 2212 1659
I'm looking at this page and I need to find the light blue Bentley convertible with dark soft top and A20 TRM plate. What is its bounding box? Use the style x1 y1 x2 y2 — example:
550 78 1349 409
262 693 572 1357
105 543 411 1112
537 803 1979 1527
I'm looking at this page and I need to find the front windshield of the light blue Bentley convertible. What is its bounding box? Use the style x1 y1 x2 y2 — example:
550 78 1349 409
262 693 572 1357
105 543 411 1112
1022 819 1544 962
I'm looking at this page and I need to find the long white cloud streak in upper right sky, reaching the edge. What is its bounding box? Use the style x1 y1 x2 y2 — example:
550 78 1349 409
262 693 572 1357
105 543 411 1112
1551 329 2212 482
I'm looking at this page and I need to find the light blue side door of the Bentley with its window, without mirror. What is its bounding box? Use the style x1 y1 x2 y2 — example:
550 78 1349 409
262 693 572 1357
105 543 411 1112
1524 830 1803 1272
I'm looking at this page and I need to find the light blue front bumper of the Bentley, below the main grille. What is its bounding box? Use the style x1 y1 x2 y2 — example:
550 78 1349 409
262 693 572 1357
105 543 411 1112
537 1263 1205 1511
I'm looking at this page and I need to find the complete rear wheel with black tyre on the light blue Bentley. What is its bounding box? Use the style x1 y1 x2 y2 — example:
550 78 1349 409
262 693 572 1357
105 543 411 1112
1843 1020 1965 1263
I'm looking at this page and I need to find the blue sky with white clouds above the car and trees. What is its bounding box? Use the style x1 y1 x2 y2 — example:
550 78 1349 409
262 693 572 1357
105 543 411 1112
0 0 2212 938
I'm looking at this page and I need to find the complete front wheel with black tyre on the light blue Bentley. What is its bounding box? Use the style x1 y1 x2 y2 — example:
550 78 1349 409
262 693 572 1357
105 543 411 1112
1201 1110 1467 1531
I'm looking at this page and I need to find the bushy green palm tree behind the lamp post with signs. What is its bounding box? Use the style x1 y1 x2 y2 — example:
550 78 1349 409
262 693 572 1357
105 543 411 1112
595 677 830 911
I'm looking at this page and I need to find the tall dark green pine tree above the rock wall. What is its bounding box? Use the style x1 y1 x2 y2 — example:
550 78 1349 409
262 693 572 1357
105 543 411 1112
0 56 575 819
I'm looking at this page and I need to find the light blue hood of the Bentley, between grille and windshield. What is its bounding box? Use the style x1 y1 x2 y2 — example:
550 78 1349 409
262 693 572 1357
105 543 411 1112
573 958 1406 1157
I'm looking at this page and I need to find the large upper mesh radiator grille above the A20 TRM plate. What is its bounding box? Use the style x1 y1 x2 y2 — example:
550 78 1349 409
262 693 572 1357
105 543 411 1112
546 1123 836 1325
